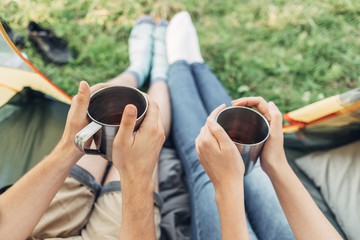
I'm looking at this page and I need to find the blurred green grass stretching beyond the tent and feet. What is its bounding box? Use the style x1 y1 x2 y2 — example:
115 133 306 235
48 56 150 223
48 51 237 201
0 0 360 113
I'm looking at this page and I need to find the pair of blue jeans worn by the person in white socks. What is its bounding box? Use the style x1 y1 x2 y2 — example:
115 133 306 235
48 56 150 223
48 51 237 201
169 61 294 239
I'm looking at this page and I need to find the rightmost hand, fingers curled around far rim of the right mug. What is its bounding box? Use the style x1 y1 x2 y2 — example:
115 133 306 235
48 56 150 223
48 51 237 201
232 97 287 175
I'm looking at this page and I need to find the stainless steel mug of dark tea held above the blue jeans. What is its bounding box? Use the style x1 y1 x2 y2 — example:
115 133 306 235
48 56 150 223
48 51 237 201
216 106 270 175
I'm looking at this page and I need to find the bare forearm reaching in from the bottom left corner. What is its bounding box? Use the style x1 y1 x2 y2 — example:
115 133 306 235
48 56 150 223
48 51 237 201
0 143 81 239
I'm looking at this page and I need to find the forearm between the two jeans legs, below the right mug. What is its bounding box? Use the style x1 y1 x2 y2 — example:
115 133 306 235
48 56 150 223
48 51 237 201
215 179 250 240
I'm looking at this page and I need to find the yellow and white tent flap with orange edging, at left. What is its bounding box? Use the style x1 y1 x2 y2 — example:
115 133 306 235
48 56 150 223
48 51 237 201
0 23 71 107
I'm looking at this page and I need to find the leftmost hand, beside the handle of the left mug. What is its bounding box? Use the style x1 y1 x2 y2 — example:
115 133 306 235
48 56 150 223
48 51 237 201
59 81 90 159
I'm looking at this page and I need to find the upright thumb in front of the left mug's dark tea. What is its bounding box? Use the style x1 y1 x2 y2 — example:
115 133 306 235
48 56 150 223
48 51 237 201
114 104 137 145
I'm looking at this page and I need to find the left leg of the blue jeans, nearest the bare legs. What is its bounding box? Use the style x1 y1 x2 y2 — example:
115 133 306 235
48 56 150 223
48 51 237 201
169 61 257 239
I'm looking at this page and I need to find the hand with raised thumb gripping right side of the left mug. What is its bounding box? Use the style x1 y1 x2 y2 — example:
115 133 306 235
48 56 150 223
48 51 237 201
113 95 165 191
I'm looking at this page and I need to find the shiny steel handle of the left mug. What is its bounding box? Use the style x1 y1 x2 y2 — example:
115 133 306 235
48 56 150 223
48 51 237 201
75 122 102 155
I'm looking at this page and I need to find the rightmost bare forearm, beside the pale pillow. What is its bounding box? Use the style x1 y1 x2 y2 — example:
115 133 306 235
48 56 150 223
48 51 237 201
269 159 341 239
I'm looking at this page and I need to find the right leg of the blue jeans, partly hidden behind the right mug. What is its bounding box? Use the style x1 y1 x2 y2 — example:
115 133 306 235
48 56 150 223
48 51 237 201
191 63 294 239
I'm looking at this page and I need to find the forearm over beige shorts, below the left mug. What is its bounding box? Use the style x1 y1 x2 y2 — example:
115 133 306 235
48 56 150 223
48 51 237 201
119 178 156 240
